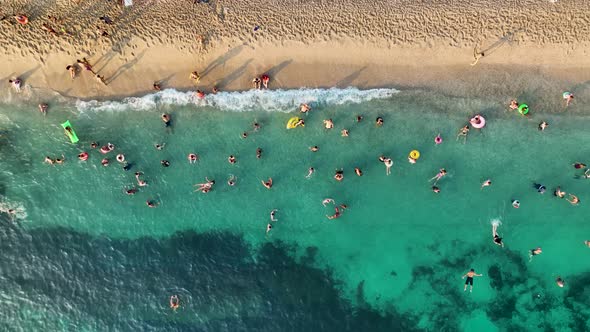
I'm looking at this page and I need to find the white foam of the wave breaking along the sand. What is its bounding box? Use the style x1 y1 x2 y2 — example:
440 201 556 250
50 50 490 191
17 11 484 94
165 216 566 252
76 87 399 112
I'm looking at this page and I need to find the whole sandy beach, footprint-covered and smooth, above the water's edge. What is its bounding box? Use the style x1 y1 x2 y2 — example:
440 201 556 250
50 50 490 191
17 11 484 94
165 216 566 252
0 0 590 101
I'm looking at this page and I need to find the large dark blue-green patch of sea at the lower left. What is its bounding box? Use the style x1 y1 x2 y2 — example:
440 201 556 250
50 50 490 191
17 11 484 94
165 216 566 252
0 227 419 332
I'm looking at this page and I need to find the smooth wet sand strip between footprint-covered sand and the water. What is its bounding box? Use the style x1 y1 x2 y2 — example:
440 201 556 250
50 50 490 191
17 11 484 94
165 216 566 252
0 41 590 105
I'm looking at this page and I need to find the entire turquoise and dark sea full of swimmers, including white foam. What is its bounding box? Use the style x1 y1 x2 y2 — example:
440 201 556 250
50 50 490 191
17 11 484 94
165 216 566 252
0 89 590 331
